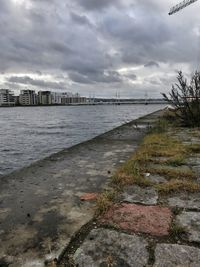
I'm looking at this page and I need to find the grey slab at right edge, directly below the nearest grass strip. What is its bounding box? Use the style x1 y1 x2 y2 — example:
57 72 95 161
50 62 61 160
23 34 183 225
168 192 200 210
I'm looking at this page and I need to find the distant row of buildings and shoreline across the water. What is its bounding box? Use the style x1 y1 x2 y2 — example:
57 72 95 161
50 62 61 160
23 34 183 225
0 88 166 107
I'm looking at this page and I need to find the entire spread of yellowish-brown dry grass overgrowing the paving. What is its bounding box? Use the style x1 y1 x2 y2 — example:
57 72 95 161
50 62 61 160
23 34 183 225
96 117 200 216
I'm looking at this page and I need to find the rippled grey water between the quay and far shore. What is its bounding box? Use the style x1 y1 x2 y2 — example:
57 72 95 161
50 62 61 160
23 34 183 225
0 105 164 174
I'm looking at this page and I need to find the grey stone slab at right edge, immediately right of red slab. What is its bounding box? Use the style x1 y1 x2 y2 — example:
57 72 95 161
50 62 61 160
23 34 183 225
176 212 200 244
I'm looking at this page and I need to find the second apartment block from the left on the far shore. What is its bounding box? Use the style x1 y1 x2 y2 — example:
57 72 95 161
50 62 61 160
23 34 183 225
19 90 38 106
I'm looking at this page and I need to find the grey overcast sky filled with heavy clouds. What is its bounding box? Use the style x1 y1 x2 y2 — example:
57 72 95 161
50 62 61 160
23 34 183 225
0 0 200 97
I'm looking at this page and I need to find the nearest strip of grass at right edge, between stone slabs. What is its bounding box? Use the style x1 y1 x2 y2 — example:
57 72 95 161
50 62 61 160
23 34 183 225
154 179 200 194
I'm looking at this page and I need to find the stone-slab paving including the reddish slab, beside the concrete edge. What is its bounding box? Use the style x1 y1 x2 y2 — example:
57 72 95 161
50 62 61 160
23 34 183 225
58 123 200 267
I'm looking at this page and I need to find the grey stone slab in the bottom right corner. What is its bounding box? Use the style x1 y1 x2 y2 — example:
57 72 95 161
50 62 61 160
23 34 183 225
153 244 200 267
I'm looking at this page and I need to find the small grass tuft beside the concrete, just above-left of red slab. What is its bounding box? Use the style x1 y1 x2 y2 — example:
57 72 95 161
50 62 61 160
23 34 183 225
96 189 117 216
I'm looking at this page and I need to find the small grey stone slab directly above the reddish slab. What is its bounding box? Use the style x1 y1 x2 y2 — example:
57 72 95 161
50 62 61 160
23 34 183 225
121 185 158 205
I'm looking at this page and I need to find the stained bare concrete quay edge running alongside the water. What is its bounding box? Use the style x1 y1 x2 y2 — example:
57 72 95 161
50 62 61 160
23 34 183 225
0 112 160 267
